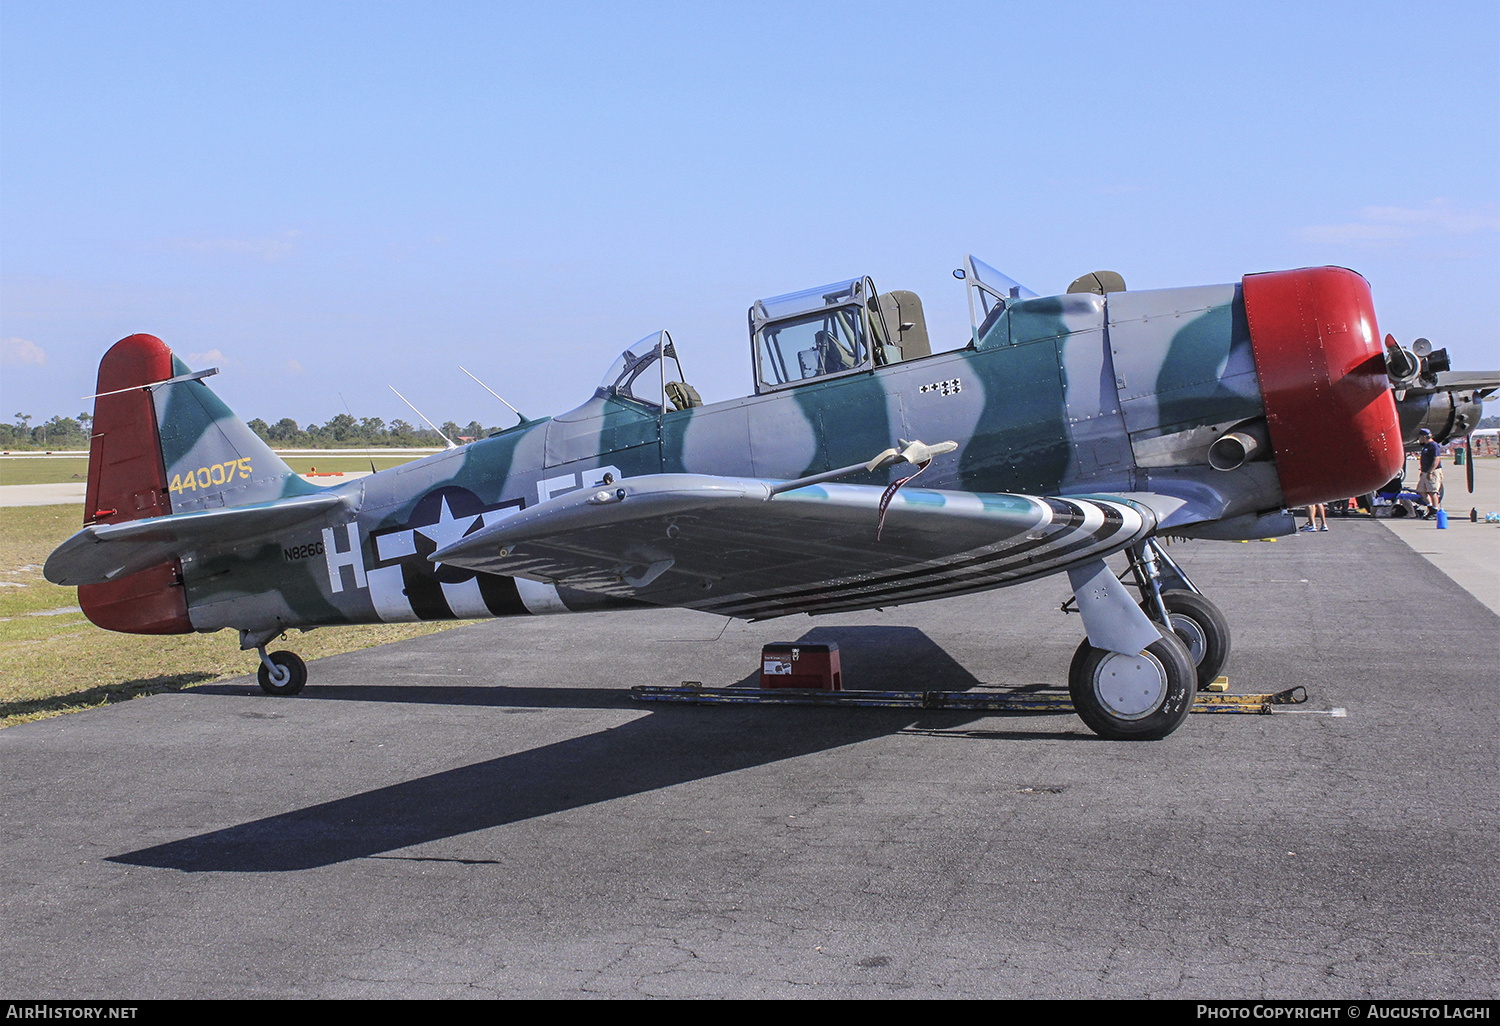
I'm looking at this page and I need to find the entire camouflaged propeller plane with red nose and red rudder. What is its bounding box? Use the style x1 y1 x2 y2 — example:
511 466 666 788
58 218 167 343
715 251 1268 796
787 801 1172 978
45 258 1470 738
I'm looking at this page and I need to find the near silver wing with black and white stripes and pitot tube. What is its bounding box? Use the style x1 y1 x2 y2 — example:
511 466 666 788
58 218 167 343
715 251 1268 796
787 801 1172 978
429 474 1157 618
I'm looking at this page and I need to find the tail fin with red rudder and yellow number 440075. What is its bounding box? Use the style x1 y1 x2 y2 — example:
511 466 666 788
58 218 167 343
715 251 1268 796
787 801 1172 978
78 335 320 635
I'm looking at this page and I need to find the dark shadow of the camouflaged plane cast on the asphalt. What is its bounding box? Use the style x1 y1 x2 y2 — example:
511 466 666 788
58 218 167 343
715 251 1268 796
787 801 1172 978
110 627 1092 873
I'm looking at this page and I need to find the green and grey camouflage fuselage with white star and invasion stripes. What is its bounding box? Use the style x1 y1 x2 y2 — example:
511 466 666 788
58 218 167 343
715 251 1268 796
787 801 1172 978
170 285 1283 636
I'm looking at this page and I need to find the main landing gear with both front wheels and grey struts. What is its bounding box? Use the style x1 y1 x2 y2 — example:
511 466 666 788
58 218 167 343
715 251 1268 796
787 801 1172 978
1064 540 1230 741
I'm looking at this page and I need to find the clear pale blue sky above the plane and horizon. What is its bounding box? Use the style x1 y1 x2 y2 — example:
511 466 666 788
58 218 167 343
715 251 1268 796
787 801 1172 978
0 0 1500 425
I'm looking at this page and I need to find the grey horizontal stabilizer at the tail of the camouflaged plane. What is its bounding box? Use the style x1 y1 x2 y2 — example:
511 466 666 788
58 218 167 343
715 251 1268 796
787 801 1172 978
42 494 347 587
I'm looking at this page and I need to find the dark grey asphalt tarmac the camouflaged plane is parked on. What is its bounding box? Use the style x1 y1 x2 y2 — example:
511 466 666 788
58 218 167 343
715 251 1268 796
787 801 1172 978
0 521 1500 999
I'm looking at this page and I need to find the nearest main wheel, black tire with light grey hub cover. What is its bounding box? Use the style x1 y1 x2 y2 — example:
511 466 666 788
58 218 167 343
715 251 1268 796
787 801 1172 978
1068 629 1197 741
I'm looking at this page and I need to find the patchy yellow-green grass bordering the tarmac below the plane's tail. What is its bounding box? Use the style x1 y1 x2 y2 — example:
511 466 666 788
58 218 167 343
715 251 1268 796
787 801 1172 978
0 504 461 728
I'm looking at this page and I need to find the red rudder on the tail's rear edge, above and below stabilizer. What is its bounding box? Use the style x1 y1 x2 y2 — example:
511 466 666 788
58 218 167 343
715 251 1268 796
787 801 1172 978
78 335 192 635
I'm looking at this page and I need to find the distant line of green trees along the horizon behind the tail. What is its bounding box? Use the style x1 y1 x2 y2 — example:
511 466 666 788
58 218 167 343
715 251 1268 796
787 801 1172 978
0 413 498 450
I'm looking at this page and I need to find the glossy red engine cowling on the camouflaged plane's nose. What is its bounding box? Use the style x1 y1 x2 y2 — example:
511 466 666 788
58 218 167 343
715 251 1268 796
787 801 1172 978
1244 267 1406 506
